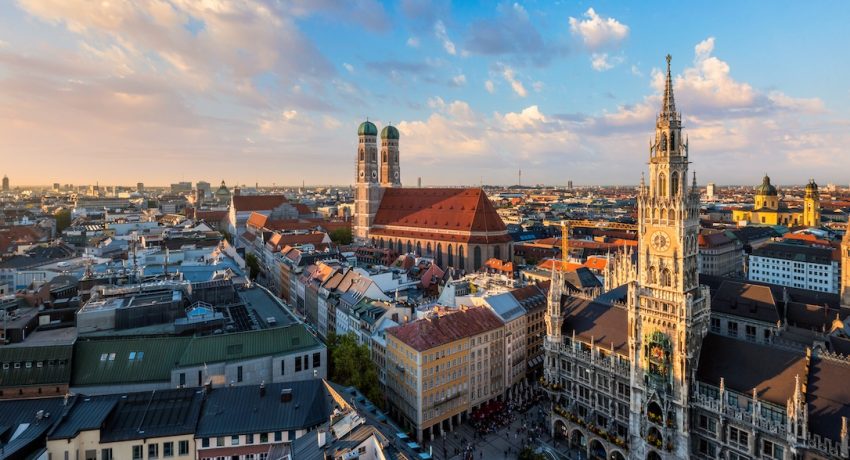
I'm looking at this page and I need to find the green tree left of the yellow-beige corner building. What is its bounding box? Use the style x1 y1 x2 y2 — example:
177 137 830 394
327 333 384 408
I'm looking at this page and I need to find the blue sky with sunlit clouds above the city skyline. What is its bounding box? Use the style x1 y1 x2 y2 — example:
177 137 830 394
0 0 850 186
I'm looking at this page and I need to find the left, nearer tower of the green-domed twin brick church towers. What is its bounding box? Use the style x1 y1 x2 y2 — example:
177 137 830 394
354 120 381 243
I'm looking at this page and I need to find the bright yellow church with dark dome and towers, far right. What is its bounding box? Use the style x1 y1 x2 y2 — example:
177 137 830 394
732 175 820 227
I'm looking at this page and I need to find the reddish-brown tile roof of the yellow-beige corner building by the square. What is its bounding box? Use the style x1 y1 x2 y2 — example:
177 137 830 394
387 307 502 351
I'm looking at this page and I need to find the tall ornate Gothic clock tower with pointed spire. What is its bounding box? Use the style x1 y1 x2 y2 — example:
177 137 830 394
628 55 709 459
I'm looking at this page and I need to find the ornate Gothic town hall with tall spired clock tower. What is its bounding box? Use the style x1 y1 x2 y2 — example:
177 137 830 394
541 55 850 460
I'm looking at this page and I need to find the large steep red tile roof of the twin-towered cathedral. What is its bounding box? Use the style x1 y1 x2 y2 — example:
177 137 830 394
370 188 510 243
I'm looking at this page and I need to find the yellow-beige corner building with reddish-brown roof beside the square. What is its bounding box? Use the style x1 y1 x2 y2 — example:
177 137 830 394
386 307 504 441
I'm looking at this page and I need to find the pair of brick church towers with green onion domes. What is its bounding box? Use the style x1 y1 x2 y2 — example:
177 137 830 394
354 120 401 241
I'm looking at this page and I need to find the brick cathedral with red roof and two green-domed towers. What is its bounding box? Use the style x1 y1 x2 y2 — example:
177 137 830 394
353 120 512 272
